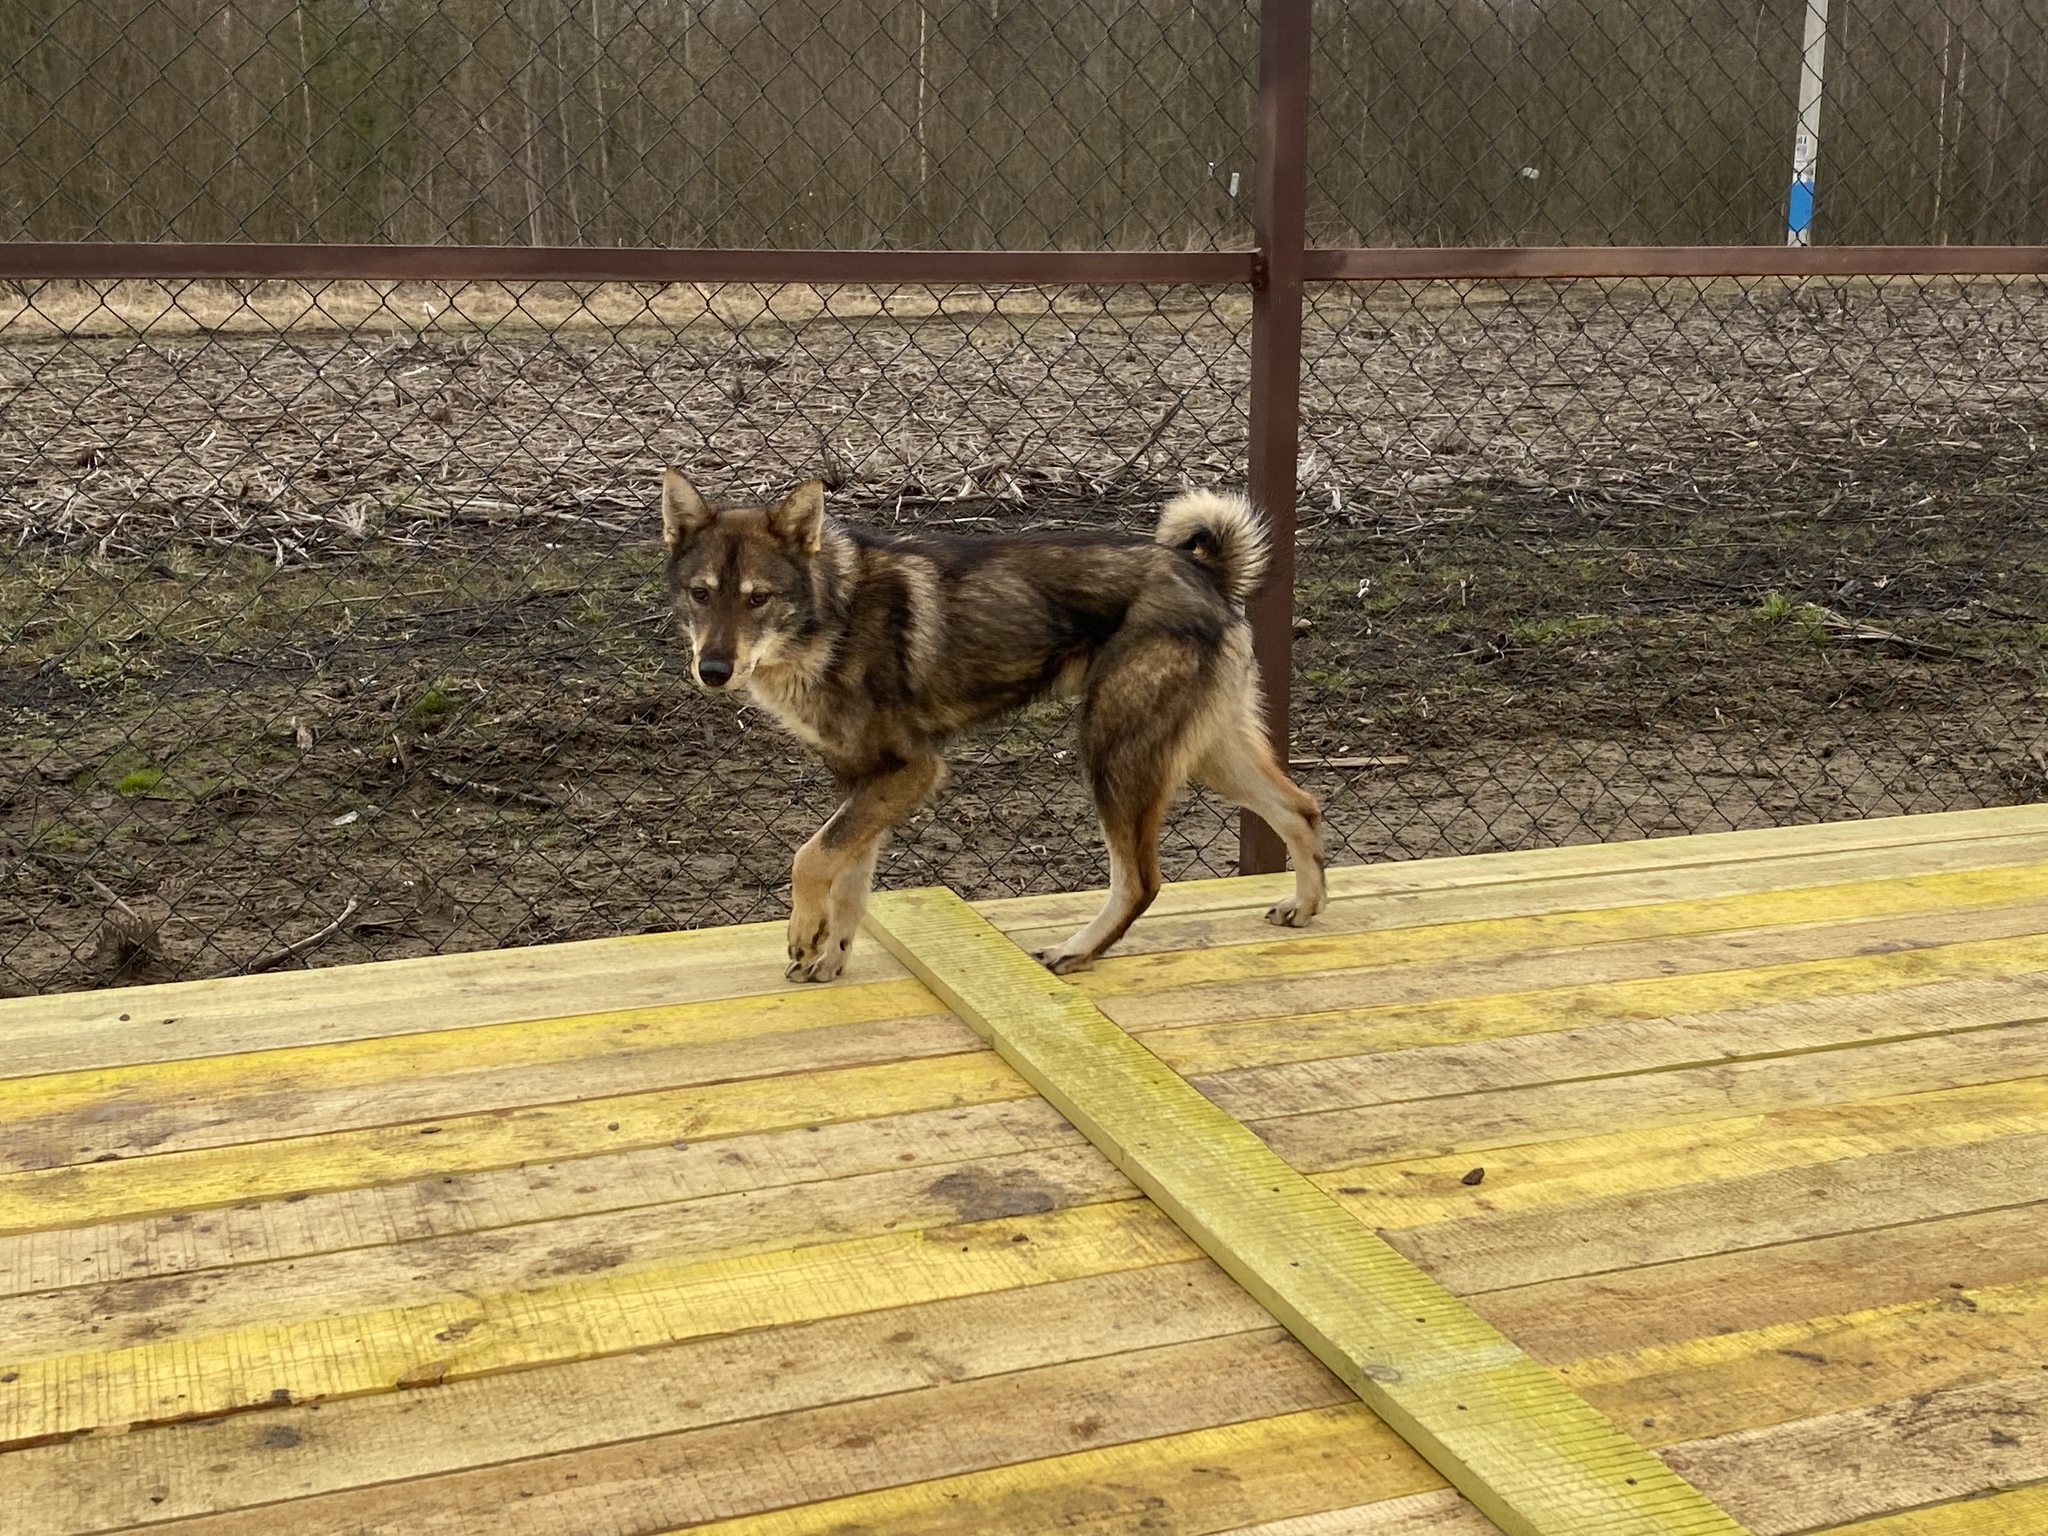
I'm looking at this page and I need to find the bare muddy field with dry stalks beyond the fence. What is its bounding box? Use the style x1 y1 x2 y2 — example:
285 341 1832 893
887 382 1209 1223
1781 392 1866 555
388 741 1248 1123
0 283 2048 991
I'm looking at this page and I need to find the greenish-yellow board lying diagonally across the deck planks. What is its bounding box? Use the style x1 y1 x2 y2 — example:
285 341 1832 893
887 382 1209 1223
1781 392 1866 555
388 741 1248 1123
868 889 1743 1536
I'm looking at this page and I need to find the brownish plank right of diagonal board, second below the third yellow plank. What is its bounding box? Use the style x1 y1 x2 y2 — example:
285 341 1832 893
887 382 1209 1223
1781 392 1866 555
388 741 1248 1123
1466 1212 2048 1364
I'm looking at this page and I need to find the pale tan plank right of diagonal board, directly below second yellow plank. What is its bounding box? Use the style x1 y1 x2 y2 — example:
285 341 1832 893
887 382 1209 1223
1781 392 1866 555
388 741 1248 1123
1196 966 2048 1120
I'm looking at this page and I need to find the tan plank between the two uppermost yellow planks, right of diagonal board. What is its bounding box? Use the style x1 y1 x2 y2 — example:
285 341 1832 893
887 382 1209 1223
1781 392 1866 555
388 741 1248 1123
1098 901 2048 1038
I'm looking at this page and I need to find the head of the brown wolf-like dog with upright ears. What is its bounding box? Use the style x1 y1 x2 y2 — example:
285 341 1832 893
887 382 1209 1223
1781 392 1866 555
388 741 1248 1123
662 469 825 692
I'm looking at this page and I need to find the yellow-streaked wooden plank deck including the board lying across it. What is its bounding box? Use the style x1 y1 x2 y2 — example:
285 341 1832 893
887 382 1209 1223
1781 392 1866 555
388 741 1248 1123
0 809 2048 1536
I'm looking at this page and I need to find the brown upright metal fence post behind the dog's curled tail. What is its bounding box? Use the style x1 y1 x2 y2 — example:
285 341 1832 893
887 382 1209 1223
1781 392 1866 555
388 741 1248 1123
1237 0 1309 874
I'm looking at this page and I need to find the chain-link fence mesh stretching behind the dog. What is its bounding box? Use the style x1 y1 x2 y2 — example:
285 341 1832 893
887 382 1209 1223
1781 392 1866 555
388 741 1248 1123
0 0 2048 989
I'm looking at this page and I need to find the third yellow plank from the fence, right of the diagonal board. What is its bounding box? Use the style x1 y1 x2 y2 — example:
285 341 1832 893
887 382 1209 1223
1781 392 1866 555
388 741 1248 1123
1315 1077 2048 1229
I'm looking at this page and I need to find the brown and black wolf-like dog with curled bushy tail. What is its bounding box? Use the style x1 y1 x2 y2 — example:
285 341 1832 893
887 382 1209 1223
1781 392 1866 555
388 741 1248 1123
662 469 1323 981
